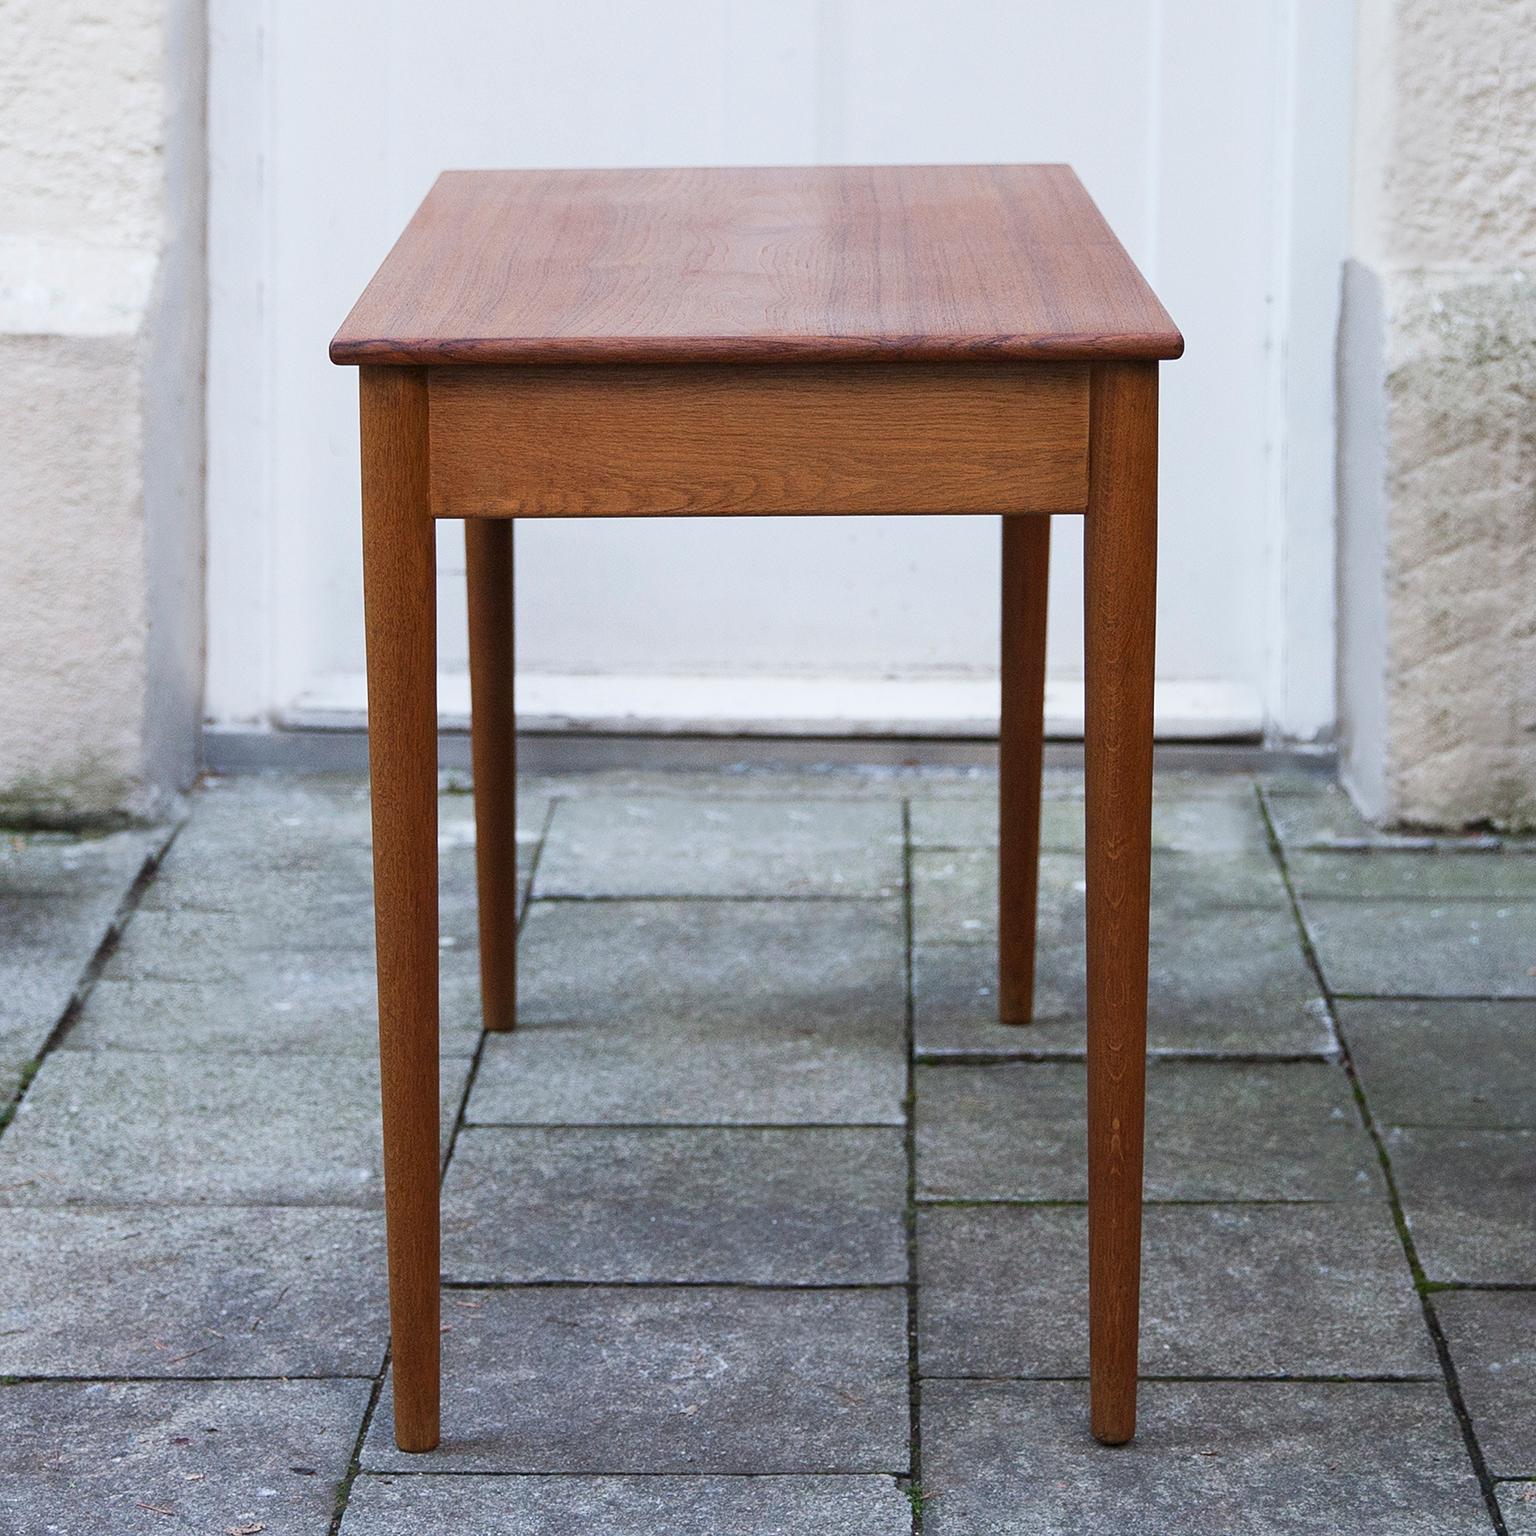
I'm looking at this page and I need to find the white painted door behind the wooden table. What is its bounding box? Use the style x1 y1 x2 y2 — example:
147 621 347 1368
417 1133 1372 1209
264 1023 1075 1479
207 0 1350 737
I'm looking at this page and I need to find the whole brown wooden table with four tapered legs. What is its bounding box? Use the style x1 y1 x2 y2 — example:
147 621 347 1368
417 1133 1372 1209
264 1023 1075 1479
330 166 1183 1452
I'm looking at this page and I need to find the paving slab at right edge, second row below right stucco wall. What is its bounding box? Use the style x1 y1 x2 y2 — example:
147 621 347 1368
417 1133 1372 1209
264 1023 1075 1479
1301 897 1536 997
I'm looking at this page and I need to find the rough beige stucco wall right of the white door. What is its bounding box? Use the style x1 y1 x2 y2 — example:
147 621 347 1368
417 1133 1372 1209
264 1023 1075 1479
1339 0 1536 826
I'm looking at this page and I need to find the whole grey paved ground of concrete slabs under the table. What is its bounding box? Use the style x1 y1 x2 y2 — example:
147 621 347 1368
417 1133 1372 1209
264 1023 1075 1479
0 770 1536 1536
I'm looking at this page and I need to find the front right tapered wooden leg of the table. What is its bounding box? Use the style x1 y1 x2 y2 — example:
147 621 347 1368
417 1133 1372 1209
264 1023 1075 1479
1083 362 1157 1445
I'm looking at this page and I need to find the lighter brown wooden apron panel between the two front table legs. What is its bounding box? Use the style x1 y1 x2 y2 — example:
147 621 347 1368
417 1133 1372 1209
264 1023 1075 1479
429 364 1087 518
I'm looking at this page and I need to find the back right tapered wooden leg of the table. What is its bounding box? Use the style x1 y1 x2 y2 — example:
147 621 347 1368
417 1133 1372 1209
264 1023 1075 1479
997 515 1051 1025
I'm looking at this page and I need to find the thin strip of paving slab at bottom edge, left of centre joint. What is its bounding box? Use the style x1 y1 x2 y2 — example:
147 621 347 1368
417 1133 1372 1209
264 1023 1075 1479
341 1473 912 1536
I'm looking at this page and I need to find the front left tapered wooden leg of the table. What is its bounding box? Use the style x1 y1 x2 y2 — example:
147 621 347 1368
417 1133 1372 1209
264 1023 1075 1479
361 367 438 1450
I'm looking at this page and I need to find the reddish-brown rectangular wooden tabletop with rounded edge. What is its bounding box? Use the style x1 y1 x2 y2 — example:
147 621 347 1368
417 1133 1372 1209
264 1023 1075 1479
330 166 1183 364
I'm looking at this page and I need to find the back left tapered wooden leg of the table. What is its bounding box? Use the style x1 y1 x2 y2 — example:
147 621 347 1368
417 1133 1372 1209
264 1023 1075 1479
464 518 518 1029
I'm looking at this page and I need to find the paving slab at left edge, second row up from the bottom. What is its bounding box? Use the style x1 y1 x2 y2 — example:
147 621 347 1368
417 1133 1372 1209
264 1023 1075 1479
0 1206 389 1378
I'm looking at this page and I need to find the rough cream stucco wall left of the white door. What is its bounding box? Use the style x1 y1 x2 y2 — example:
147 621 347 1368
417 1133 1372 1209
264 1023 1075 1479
0 0 206 820
